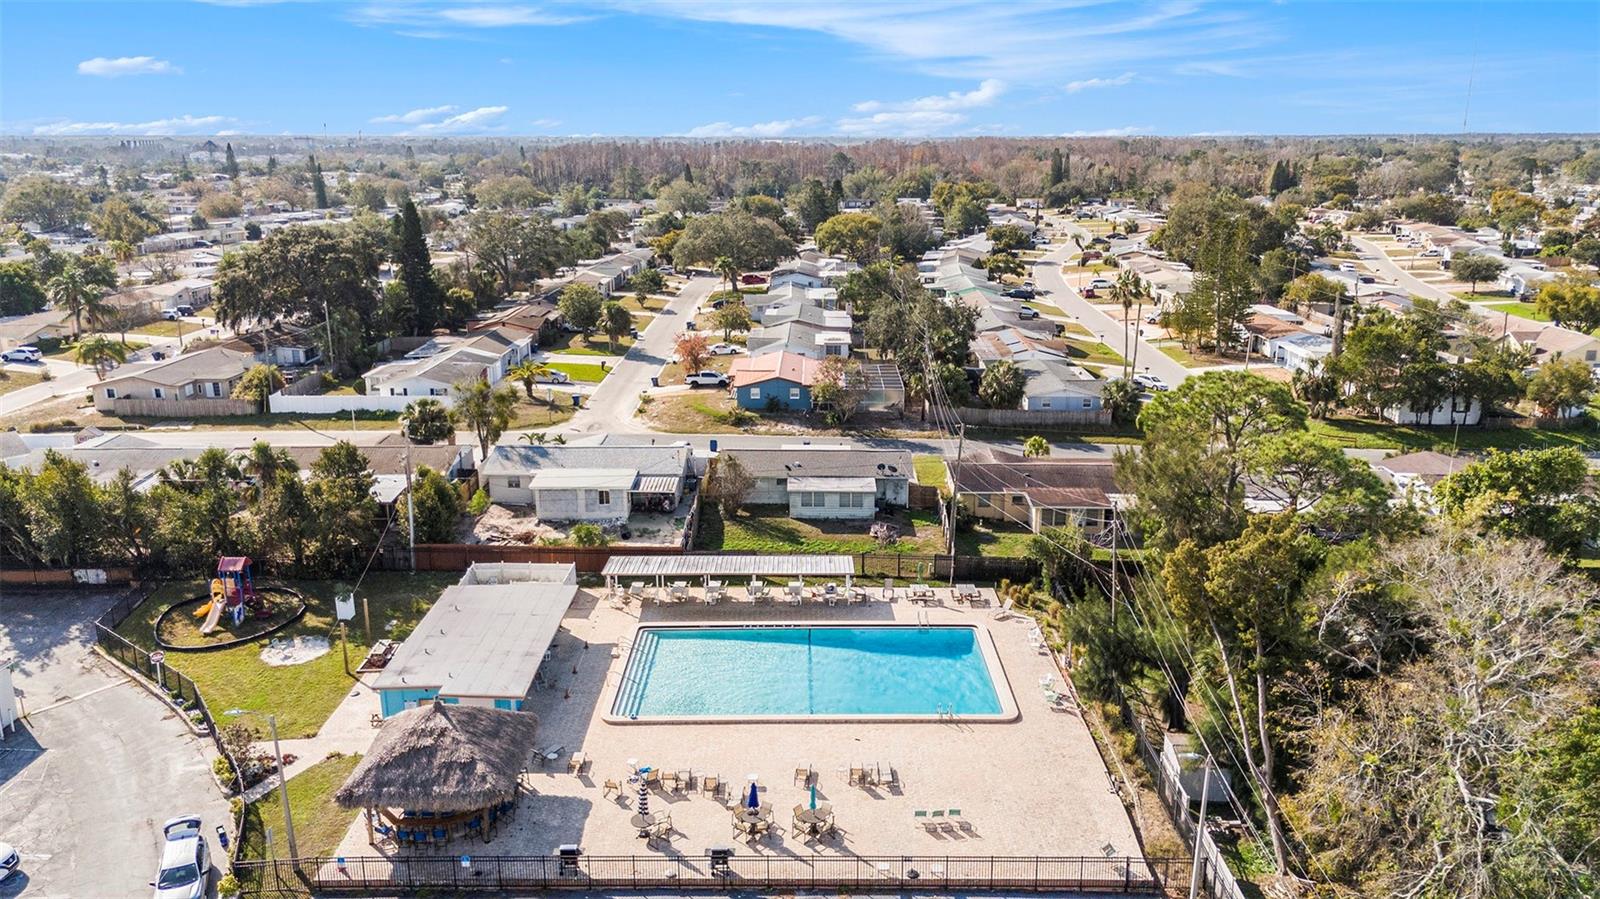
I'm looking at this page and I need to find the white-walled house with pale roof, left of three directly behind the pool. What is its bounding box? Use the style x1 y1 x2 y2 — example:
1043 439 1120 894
478 445 694 525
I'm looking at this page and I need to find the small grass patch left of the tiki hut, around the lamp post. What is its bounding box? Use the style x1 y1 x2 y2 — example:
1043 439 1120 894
242 755 362 859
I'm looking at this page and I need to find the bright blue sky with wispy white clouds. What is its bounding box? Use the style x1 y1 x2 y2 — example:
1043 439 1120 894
0 0 1600 138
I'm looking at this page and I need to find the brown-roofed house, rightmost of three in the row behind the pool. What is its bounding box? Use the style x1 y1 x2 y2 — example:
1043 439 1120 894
950 450 1128 534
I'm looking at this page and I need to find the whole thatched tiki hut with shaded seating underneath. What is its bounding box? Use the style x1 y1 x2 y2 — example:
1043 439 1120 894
333 701 539 848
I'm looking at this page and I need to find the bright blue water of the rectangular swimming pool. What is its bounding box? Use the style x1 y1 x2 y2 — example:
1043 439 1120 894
611 627 1002 718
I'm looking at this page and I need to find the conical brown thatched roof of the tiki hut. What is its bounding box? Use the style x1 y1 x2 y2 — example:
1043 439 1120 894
333 702 539 813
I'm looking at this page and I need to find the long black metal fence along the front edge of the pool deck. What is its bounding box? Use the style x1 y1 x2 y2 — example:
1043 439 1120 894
234 854 1218 899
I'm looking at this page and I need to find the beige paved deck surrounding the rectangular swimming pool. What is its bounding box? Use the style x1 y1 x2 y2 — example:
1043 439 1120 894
338 589 1139 857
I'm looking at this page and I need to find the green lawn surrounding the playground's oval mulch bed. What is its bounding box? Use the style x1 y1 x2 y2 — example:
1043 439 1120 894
117 571 461 739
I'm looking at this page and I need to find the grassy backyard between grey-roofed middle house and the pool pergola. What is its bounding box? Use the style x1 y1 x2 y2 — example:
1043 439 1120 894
694 502 944 555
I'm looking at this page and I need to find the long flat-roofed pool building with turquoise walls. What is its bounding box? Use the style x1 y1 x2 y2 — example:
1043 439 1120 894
373 565 578 718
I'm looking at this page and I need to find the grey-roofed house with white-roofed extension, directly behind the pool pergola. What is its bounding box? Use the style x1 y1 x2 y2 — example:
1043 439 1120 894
718 446 915 518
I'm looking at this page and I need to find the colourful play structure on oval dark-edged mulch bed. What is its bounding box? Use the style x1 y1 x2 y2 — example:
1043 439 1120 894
154 555 306 653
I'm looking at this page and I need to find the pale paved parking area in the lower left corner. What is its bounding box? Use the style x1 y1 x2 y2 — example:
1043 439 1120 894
0 592 227 899
